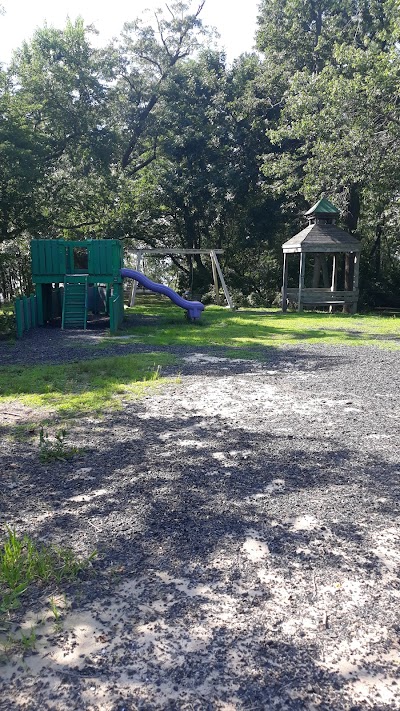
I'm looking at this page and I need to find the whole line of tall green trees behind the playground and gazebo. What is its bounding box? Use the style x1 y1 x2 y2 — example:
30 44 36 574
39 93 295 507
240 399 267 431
0 0 400 306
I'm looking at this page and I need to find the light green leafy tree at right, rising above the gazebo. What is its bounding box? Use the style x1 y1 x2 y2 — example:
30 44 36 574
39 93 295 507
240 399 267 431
259 0 400 304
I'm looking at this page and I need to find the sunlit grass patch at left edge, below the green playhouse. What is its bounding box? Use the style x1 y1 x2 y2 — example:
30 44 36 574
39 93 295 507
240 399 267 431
0 353 175 418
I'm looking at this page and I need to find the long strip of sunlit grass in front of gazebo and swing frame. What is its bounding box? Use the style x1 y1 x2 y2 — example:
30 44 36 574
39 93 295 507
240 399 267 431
106 297 400 356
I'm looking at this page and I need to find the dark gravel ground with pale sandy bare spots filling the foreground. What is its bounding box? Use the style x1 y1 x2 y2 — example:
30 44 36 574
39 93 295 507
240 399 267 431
0 330 400 711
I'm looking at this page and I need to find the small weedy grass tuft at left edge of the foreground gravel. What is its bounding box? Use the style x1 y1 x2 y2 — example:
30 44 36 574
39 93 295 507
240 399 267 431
0 529 96 621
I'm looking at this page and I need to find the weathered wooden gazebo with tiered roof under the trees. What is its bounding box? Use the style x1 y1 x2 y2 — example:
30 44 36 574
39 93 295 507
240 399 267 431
282 198 361 313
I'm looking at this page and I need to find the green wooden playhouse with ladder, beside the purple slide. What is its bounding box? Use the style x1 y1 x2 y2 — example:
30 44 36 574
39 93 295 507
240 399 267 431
16 239 124 331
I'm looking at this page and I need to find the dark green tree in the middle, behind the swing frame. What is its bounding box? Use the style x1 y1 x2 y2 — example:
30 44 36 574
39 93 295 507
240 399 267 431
115 51 278 299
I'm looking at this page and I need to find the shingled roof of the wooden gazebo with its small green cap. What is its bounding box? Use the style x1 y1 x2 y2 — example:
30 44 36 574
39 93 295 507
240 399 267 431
282 225 361 253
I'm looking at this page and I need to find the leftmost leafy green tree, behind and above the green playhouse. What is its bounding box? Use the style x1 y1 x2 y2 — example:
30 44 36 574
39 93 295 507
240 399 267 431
0 20 114 239
